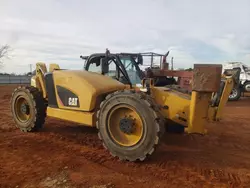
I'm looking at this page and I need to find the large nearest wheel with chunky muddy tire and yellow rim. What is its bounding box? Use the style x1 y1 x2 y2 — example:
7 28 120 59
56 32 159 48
97 91 162 161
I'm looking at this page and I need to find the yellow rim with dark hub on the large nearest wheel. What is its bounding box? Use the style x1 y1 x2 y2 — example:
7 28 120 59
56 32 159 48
107 105 143 147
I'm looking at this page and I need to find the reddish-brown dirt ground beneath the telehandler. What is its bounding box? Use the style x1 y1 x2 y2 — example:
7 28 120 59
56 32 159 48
0 86 250 188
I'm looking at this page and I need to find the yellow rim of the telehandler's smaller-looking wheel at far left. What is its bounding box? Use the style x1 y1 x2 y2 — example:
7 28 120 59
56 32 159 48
14 96 30 123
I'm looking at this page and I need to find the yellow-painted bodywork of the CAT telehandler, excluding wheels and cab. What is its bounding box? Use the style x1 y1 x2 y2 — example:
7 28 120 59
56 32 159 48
31 63 238 134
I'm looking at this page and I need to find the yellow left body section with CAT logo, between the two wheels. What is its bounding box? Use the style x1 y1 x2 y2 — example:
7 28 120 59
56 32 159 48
31 63 126 126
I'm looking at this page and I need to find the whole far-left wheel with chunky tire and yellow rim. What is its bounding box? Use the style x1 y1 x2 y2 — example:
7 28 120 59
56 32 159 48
11 86 46 132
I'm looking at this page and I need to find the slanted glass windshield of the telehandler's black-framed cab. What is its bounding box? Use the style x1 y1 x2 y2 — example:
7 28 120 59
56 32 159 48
120 56 141 85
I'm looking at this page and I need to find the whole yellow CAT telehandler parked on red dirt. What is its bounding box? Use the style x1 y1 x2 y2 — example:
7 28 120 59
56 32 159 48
11 51 238 161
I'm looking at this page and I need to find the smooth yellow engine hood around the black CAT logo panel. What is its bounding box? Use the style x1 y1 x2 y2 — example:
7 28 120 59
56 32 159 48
53 70 125 112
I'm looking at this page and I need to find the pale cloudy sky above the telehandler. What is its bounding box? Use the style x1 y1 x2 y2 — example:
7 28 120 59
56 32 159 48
0 0 250 73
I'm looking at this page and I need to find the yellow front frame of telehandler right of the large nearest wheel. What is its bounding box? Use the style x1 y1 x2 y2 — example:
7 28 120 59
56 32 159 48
151 70 237 134
